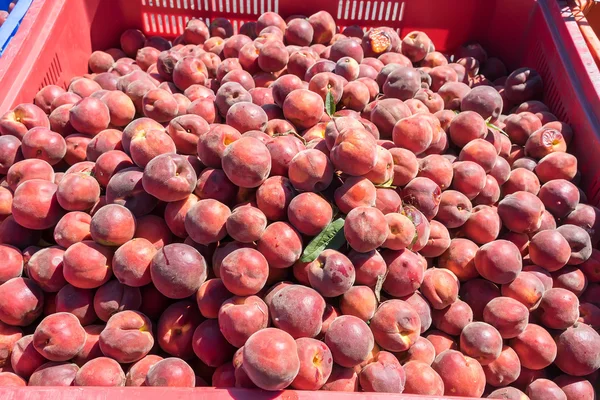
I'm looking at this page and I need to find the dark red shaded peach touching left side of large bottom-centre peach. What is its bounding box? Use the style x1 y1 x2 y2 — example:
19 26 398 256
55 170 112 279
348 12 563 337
192 319 235 367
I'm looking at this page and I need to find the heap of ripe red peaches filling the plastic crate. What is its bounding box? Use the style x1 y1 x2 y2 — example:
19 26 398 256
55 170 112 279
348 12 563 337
0 11 600 400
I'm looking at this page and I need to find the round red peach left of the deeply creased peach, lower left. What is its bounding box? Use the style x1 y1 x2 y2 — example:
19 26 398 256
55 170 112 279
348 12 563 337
33 312 86 361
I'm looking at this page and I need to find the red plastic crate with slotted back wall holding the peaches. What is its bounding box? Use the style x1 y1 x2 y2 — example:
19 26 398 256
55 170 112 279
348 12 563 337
0 0 600 400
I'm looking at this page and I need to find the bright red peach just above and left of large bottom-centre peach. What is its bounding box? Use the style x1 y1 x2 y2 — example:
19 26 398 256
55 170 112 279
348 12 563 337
218 296 269 347
